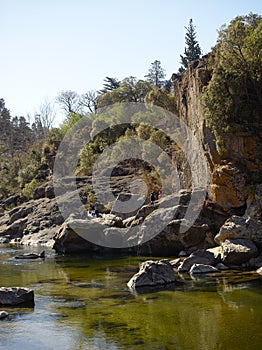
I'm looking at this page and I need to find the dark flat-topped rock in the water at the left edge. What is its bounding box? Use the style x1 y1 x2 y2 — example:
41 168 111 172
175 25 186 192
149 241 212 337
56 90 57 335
0 287 34 305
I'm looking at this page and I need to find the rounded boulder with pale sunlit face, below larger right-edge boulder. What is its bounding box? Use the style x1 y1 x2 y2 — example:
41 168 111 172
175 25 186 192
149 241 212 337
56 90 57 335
221 238 258 265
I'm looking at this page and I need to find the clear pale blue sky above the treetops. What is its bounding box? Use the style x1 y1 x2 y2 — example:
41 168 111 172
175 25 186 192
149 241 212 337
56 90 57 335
0 0 262 124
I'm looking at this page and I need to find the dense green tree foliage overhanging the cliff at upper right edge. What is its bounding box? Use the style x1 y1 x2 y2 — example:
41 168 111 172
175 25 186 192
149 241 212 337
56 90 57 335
203 14 262 152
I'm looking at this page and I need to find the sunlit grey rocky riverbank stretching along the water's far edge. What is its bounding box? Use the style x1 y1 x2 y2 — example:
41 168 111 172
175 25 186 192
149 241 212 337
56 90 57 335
0 179 262 272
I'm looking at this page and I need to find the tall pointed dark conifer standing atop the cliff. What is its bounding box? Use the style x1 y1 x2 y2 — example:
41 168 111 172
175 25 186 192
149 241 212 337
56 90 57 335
179 18 201 73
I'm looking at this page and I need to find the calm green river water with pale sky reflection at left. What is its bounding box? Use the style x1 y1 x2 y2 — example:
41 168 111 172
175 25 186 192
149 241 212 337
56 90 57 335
0 247 262 350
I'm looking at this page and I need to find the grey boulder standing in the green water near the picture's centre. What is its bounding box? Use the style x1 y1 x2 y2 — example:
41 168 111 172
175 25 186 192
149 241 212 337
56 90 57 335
127 260 175 289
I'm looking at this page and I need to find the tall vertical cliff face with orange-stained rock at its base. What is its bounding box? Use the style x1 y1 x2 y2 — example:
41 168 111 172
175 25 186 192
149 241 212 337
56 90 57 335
172 55 262 212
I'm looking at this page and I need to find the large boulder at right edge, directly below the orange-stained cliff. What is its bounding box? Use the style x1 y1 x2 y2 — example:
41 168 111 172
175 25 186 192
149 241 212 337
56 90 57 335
215 215 262 245
